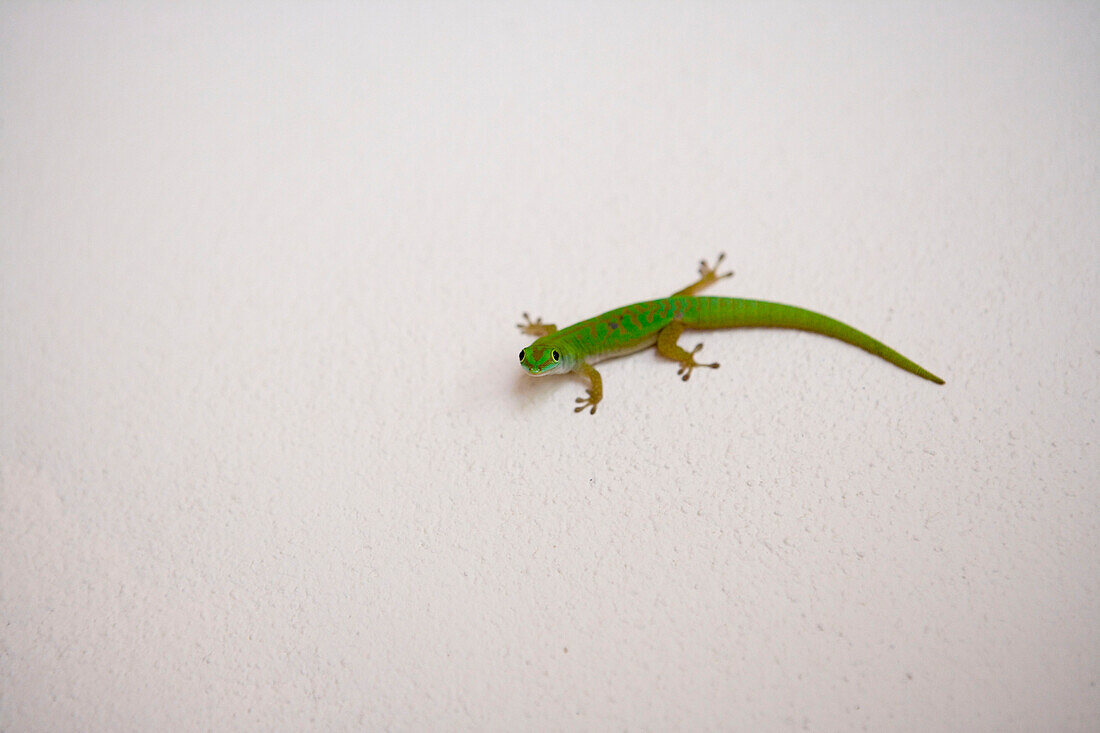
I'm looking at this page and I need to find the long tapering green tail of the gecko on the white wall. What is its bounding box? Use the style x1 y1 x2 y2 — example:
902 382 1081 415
696 298 944 384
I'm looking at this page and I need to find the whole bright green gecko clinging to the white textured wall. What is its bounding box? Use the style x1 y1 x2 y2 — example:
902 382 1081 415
516 254 944 415
